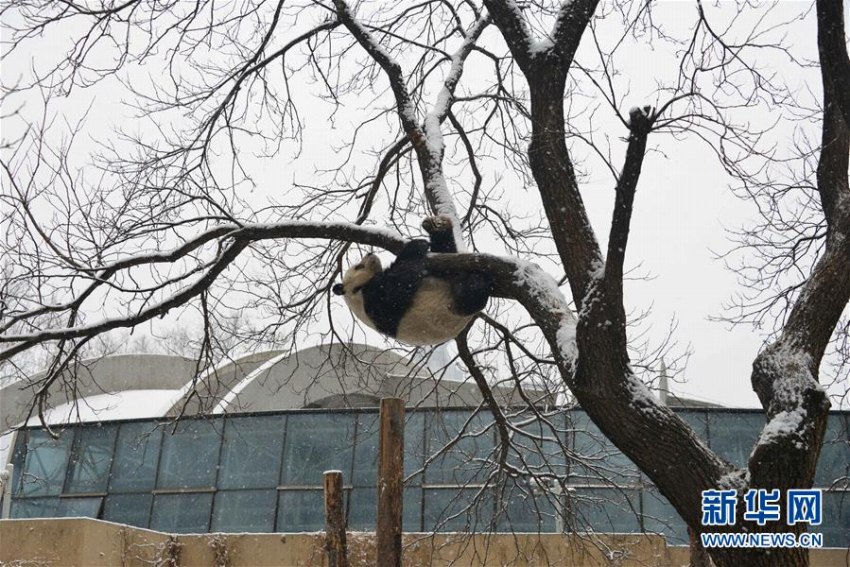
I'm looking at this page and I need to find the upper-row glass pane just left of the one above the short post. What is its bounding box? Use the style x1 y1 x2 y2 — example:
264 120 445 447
218 415 286 490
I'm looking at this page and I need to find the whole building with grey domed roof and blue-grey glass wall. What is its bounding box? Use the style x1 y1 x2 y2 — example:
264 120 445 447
0 347 850 547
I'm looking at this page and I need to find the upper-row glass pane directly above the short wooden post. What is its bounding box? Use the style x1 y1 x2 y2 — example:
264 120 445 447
281 413 354 486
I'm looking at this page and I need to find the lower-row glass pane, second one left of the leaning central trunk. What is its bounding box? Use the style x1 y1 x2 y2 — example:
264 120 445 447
568 488 640 533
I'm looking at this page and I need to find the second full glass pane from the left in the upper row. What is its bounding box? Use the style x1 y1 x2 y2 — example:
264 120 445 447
65 425 118 494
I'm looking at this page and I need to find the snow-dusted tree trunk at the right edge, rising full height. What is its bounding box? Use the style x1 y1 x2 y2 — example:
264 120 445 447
712 0 850 566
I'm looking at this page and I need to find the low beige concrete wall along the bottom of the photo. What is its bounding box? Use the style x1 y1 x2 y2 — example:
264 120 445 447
0 518 848 567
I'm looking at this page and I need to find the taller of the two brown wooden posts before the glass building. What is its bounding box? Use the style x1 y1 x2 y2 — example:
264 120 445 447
377 398 404 567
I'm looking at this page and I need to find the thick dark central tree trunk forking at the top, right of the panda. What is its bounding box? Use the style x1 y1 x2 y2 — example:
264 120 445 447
486 0 732 548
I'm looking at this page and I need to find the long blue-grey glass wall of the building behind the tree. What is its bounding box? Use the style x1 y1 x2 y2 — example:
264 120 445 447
12 409 850 547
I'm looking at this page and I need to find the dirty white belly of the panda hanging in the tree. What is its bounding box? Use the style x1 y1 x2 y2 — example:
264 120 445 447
396 277 472 346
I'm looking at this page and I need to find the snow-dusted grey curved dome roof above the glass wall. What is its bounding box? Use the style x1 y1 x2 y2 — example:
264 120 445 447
0 343 548 431
